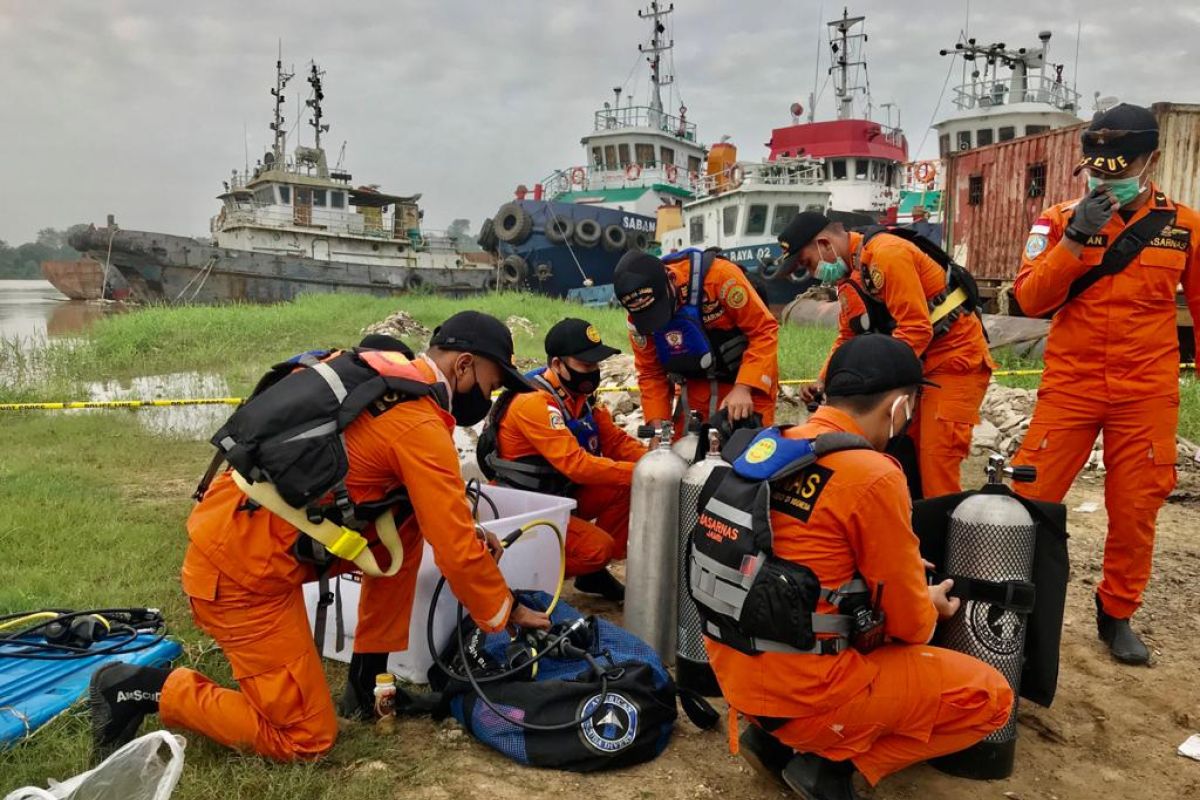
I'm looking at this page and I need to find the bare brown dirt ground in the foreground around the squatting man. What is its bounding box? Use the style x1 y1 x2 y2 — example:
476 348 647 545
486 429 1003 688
386 463 1200 800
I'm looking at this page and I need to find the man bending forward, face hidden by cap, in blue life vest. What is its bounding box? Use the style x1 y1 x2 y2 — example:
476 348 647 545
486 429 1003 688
612 249 779 435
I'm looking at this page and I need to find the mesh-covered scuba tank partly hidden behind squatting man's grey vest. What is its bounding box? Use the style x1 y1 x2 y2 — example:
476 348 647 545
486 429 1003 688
676 431 730 697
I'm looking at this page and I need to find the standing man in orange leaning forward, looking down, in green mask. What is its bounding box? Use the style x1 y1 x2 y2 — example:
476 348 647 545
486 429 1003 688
779 211 995 498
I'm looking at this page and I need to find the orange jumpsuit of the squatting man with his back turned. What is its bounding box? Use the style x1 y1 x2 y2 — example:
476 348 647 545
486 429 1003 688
706 405 1013 783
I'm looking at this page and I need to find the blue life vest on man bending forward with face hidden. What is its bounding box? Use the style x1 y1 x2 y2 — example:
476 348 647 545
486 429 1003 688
654 247 749 383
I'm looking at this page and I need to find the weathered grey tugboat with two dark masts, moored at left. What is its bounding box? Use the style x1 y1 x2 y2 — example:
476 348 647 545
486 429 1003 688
70 56 496 303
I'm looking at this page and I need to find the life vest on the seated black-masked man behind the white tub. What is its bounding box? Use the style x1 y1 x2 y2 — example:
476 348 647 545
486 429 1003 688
475 367 600 495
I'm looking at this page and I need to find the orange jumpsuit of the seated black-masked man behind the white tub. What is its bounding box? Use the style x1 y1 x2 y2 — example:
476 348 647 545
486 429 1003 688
496 369 646 577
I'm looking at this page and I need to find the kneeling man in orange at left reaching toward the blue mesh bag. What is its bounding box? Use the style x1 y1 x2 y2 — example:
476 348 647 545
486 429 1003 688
90 311 550 762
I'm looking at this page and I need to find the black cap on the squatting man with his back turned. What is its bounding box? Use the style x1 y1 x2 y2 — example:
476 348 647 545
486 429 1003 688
824 333 937 397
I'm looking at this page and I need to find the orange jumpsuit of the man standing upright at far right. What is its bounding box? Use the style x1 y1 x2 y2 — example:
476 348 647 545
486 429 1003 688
1013 186 1200 619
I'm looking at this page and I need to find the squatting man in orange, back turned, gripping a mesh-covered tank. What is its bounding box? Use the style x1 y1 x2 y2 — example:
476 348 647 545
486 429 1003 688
706 336 1013 800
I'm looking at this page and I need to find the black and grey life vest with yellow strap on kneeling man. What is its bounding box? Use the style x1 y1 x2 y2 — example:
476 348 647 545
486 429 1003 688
194 349 449 577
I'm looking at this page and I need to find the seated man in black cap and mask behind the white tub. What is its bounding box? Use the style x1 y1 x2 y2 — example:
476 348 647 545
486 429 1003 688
476 319 646 601
